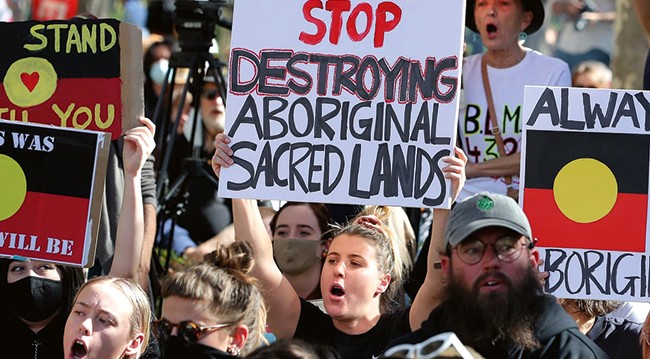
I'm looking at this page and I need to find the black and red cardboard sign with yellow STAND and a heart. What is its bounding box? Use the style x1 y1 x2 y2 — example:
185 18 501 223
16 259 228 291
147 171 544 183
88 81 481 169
0 19 144 138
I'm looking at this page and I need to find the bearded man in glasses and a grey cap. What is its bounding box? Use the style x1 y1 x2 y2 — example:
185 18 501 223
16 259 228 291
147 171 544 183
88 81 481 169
382 193 607 359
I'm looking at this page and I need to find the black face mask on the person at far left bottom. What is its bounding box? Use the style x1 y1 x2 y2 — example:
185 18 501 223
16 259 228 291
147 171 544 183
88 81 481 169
7 276 63 322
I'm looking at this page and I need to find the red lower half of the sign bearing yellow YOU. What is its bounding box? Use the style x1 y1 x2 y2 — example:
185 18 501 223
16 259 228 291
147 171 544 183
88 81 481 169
0 78 122 139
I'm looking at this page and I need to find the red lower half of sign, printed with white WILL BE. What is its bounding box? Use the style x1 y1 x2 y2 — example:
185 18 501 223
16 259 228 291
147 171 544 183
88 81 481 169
0 192 90 264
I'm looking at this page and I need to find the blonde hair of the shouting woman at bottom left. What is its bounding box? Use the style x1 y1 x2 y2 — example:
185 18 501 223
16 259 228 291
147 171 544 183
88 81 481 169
73 276 152 357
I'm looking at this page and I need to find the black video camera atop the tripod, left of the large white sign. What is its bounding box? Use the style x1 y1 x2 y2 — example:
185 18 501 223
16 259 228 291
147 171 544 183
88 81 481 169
174 0 232 51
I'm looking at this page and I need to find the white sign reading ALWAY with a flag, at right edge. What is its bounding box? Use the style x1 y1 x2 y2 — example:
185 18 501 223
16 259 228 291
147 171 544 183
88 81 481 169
520 87 650 301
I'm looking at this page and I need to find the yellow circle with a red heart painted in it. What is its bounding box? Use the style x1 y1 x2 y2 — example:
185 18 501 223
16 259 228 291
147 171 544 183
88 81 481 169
3 57 58 107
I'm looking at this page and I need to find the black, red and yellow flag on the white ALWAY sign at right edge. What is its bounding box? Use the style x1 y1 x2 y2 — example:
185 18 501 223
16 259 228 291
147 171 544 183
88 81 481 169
523 130 650 252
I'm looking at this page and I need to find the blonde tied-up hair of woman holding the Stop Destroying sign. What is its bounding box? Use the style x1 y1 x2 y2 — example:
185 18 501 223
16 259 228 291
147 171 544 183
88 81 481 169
334 206 410 313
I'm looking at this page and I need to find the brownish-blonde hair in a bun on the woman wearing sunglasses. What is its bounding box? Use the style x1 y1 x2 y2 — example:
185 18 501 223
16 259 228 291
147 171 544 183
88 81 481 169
162 242 266 355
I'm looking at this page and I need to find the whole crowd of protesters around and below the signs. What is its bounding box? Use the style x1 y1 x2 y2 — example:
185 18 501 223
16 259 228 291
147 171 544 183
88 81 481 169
0 0 650 359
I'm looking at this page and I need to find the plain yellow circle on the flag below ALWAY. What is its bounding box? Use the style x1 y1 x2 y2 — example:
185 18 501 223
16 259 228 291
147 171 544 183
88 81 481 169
553 158 618 223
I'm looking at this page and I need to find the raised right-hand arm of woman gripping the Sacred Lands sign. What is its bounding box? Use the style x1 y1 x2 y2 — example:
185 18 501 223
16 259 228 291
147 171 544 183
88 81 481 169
409 148 467 330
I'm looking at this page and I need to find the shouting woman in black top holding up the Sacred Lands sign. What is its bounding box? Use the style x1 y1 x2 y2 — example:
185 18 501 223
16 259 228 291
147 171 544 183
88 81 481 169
212 134 467 359
